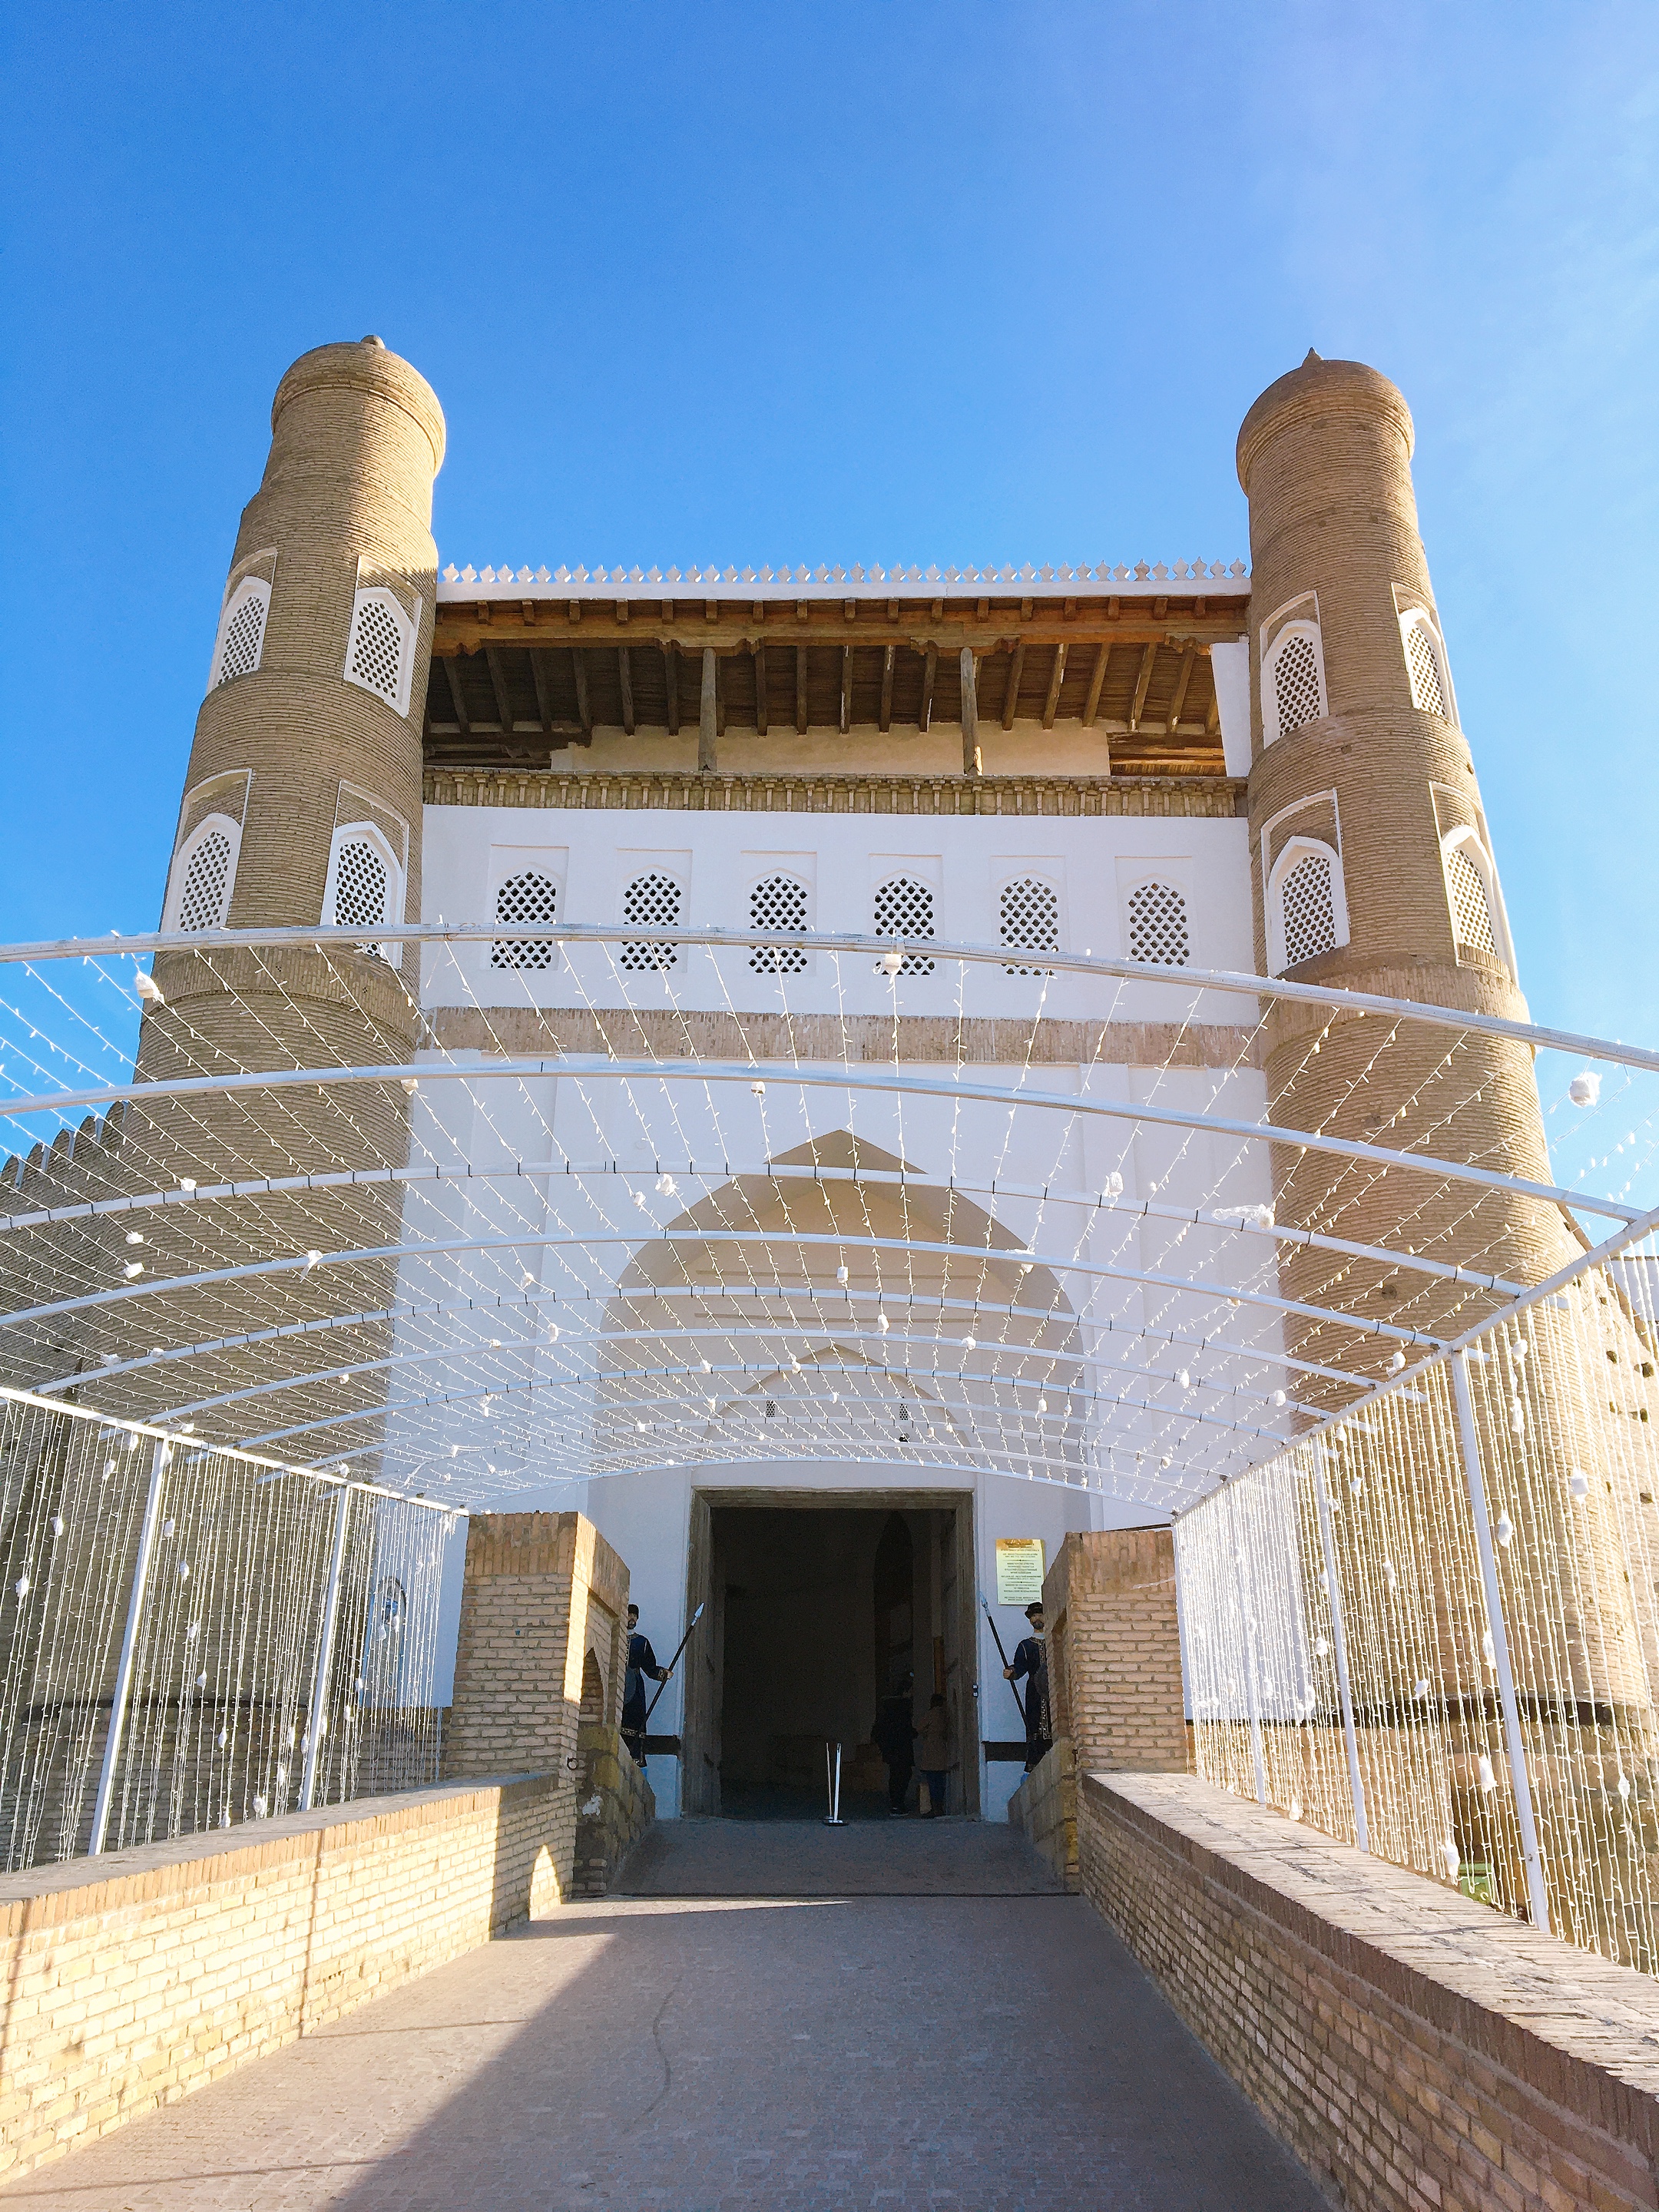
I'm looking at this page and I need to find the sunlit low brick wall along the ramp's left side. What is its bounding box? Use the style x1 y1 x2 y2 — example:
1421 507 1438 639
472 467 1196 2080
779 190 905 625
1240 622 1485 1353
0 1774 568 2179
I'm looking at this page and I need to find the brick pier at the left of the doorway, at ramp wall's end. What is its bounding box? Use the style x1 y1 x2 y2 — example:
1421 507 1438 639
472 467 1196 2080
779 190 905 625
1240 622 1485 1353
442 1513 628 1898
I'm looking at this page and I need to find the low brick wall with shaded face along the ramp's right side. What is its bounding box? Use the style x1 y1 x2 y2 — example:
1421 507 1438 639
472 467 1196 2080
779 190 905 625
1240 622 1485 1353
1078 1774 1659 2212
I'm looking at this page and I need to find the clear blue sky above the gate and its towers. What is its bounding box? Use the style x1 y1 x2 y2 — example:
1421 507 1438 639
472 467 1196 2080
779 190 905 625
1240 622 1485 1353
0 0 1659 1041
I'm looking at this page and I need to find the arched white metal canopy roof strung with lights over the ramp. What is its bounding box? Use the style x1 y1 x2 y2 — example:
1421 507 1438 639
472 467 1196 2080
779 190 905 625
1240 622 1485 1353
0 922 1659 1511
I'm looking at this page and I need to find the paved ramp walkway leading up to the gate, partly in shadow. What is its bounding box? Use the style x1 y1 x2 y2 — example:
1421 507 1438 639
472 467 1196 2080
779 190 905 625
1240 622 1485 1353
0 1820 1323 2212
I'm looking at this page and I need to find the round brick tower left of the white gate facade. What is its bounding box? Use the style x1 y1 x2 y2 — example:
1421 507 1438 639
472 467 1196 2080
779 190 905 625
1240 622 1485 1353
121 339 445 1458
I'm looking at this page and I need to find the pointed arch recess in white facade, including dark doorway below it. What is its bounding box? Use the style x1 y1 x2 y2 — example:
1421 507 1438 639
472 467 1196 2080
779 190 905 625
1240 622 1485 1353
595 1131 1084 1814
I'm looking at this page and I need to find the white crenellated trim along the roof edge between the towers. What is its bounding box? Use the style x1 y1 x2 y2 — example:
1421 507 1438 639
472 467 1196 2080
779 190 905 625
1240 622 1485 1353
438 560 1250 604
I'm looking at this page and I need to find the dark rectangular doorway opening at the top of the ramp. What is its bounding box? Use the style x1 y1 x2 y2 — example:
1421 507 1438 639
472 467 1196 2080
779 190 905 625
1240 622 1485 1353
681 1491 980 1820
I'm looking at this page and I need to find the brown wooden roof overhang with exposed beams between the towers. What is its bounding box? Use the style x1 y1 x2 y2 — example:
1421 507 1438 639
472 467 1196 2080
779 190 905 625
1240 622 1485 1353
425 586 1250 777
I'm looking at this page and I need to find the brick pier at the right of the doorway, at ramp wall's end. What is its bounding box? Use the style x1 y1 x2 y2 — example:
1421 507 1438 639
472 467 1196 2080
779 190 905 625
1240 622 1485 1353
1041 1528 1190 1772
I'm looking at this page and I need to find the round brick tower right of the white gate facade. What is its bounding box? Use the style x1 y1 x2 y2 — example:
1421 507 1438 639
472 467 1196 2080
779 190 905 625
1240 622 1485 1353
1239 354 1654 1919
